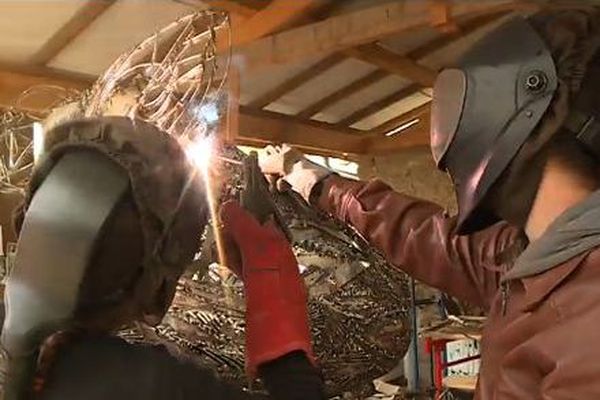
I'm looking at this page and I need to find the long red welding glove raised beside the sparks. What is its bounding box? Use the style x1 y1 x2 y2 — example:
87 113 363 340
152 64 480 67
220 201 314 377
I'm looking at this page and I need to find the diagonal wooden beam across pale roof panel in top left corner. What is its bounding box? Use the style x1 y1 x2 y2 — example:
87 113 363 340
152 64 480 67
29 0 116 65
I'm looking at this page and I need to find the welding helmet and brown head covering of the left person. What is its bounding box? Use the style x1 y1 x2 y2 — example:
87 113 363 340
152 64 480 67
1 117 207 399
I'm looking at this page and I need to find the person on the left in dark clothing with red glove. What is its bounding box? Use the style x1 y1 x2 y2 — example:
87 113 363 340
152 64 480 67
1 117 324 400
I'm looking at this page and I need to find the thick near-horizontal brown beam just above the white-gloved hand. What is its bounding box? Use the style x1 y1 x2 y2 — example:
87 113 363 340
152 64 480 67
236 107 366 156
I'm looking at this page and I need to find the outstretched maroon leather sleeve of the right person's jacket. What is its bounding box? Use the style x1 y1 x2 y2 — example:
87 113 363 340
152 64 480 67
318 175 517 310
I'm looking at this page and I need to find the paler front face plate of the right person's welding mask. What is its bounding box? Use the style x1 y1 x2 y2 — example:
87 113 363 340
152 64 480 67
431 69 467 169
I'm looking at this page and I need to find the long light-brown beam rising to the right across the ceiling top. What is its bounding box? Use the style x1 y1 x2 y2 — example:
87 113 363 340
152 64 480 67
235 0 520 72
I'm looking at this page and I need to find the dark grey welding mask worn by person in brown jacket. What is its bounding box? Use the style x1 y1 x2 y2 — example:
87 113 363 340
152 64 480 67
431 17 558 234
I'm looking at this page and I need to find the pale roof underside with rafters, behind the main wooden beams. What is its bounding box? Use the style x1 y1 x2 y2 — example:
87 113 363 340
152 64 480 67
0 0 544 155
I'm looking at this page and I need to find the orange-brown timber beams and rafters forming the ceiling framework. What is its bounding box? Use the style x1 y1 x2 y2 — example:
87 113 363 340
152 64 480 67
0 0 536 156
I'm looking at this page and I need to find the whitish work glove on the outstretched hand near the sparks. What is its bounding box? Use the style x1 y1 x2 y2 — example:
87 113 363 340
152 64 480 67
258 144 332 201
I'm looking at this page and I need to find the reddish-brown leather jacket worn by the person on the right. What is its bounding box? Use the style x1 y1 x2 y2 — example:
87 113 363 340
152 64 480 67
318 176 600 400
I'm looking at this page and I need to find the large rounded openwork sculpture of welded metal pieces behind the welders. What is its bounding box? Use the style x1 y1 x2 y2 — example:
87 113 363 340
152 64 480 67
0 12 410 396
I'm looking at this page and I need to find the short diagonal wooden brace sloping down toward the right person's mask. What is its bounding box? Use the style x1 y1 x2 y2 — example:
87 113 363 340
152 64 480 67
344 43 437 87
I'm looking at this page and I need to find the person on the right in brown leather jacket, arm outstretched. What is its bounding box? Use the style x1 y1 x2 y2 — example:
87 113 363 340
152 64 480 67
260 7 600 399
